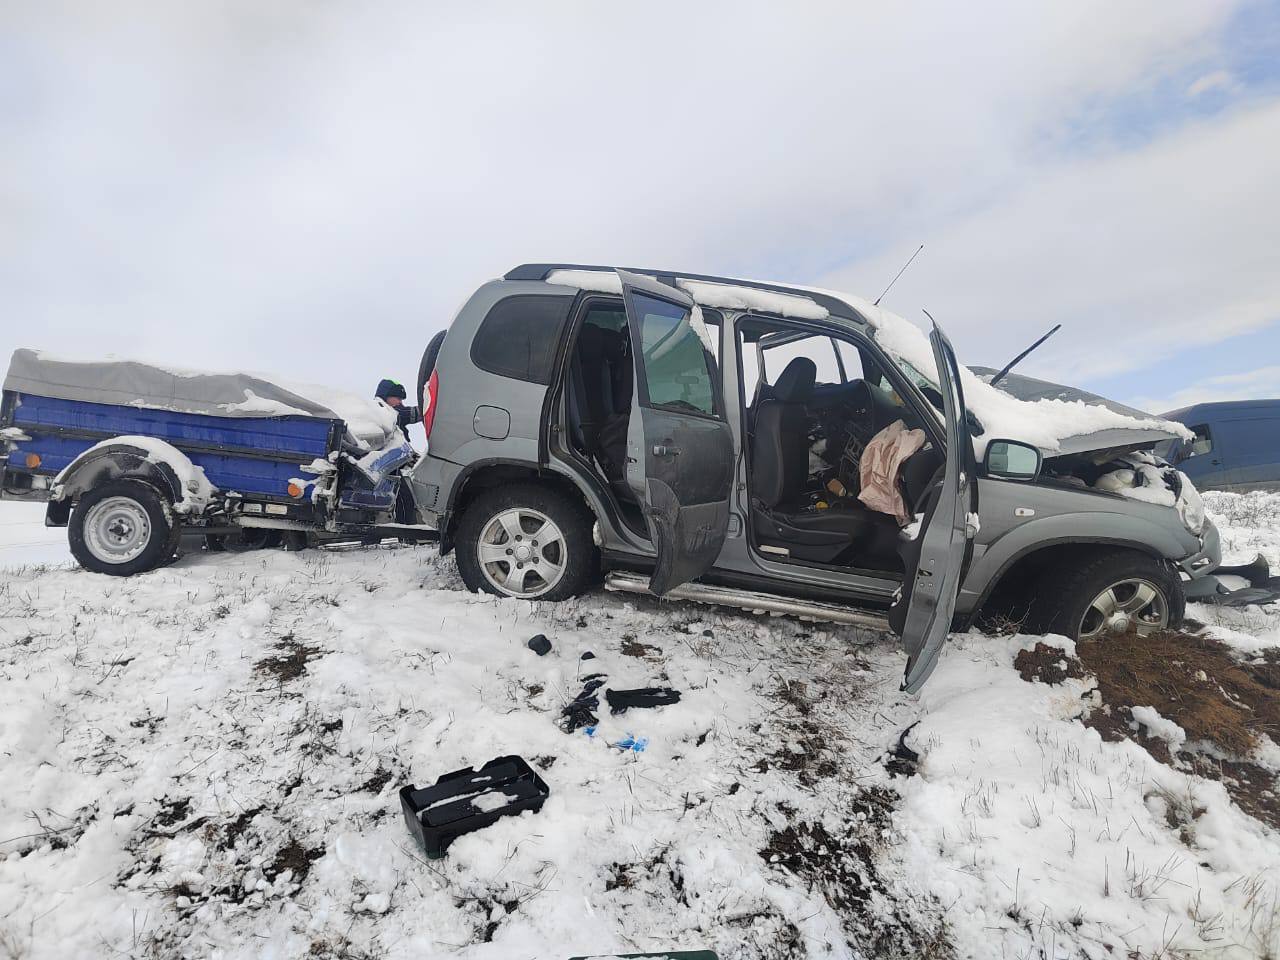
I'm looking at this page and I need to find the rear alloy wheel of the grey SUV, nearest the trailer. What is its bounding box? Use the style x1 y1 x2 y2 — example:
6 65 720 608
456 484 595 600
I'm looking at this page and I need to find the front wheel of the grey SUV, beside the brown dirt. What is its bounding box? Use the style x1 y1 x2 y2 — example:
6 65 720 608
1028 550 1187 640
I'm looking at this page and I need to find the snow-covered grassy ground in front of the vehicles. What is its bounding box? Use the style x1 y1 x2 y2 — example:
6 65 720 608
0 494 1280 960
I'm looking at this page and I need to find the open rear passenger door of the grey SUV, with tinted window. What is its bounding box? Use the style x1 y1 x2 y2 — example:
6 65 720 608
618 270 733 595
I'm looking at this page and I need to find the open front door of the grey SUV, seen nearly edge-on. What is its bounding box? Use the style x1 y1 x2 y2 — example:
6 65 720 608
888 324 977 694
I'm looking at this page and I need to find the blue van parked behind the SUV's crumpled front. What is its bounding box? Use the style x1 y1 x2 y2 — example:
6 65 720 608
1156 399 1280 493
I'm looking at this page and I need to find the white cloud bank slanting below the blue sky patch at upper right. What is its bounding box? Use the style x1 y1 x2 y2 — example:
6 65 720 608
824 101 1280 383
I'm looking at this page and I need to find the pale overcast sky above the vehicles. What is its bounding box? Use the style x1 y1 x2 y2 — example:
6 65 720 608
0 0 1280 411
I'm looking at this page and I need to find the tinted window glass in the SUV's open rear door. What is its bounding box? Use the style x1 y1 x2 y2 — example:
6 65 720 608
632 293 716 415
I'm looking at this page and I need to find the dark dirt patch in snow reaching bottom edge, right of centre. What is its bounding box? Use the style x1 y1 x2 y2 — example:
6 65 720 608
760 787 954 957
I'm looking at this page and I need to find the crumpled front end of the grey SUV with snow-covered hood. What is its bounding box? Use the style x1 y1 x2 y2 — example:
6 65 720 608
865 310 1267 624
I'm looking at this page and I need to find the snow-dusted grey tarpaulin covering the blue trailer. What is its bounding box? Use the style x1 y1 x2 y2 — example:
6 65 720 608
4 349 397 448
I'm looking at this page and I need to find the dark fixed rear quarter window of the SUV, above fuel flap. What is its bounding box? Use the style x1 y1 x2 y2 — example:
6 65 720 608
471 294 573 384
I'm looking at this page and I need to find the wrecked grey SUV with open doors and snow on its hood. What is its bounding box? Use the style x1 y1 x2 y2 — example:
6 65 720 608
411 264 1220 691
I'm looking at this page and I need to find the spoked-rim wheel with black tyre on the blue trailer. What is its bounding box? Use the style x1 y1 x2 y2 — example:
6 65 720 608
67 480 182 577
